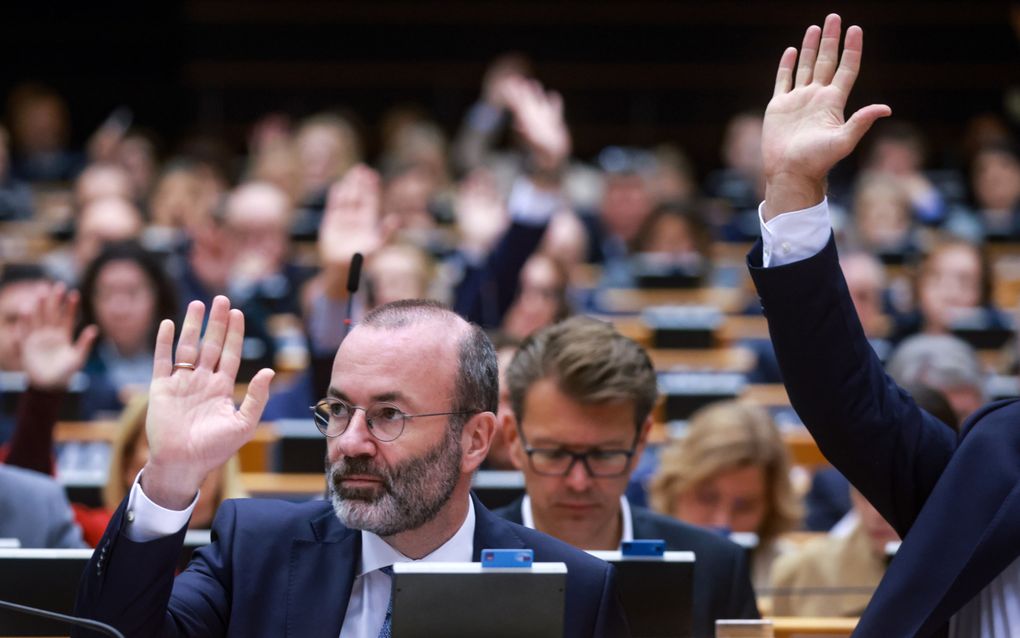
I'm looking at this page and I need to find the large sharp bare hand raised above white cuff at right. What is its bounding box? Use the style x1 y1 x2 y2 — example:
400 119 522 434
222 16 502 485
762 13 893 220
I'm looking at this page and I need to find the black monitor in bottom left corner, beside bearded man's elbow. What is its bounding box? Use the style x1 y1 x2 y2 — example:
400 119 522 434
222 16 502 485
0 549 92 636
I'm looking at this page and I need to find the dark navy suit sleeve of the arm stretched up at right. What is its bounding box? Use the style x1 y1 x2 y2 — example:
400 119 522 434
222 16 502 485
749 235 957 536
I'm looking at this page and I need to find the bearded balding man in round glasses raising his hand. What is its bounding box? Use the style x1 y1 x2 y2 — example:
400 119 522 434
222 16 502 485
77 297 627 638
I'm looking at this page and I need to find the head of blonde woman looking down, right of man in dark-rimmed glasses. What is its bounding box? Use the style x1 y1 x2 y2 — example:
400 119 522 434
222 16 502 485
650 401 801 589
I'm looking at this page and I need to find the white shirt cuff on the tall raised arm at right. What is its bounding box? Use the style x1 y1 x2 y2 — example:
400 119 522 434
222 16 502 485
758 198 832 267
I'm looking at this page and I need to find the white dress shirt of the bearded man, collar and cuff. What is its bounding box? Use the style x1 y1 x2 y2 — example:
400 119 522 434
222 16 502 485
124 474 474 638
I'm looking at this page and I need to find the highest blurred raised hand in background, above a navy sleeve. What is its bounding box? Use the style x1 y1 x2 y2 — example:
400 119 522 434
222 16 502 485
503 77 570 174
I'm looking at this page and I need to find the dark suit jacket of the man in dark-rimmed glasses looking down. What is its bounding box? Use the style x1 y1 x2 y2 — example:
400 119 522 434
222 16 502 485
493 499 758 638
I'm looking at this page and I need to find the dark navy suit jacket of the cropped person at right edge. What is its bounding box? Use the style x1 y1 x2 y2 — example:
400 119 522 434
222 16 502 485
749 238 1020 636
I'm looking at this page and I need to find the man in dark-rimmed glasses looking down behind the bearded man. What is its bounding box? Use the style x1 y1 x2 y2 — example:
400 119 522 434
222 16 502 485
496 316 758 636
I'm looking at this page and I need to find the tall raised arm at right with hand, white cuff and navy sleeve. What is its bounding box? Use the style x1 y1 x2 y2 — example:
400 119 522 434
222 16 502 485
749 15 957 536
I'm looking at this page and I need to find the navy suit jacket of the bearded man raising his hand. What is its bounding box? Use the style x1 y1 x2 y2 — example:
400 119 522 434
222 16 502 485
75 492 629 638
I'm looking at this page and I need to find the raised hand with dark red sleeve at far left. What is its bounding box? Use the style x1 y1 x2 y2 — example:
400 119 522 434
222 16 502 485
21 284 99 390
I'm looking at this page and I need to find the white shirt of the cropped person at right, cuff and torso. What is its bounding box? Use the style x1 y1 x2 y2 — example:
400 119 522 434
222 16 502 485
758 199 1020 638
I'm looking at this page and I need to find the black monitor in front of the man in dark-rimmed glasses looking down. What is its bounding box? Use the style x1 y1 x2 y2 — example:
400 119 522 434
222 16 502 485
589 551 695 638
